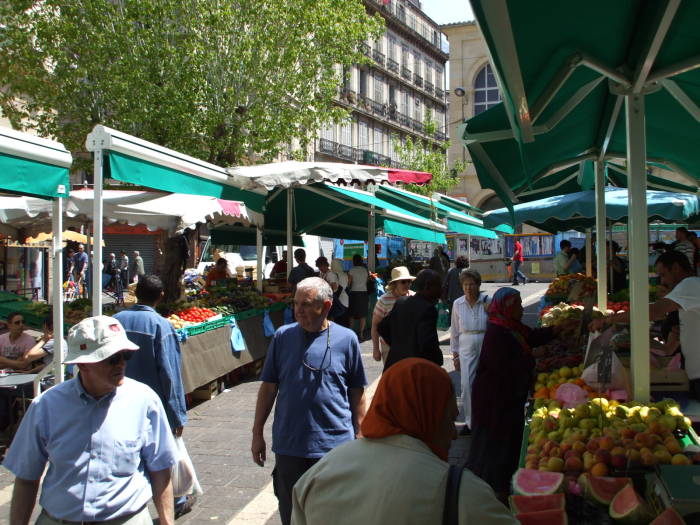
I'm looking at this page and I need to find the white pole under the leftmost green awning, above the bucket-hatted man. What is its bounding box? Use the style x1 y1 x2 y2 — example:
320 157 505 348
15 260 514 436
51 197 65 385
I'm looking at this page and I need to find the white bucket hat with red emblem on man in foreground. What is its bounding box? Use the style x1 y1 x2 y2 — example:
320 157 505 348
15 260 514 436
64 315 139 365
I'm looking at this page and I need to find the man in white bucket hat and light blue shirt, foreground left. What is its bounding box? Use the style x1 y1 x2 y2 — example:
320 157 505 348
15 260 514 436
3 315 177 525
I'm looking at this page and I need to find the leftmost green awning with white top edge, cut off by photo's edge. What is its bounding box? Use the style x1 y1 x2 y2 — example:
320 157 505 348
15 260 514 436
0 128 72 198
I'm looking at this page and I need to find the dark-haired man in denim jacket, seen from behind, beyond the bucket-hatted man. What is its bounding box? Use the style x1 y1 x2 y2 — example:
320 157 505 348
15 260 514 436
114 275 196 517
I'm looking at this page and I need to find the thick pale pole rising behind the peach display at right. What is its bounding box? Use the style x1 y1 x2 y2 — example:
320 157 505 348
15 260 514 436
625 94 649 402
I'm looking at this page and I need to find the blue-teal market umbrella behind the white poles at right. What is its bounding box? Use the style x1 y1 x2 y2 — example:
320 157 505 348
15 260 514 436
484 187 700 233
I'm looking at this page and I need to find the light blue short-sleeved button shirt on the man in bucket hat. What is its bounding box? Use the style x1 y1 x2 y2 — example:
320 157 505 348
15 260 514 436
3 377 177 521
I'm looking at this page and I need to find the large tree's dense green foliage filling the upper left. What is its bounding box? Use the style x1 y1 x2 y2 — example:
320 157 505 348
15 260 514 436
0 0 382 165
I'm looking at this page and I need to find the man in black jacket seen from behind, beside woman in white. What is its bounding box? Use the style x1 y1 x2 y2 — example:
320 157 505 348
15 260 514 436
384 270 442 370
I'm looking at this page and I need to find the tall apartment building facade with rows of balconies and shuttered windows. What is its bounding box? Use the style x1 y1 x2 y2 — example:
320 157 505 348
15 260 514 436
314 0 449 167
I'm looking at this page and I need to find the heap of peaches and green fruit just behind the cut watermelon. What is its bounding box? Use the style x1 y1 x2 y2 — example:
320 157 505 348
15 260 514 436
525 398 697 476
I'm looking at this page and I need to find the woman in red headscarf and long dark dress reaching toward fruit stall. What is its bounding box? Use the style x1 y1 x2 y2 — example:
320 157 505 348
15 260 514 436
467 287 553 500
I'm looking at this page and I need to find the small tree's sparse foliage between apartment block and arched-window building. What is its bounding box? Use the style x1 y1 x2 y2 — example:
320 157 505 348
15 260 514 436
394 115 466 195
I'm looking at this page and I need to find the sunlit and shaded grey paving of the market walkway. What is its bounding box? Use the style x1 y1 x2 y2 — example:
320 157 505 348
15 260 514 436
0 283 547 525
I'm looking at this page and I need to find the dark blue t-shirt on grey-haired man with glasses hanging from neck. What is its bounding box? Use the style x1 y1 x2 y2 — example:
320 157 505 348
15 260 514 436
261 323 367 458
